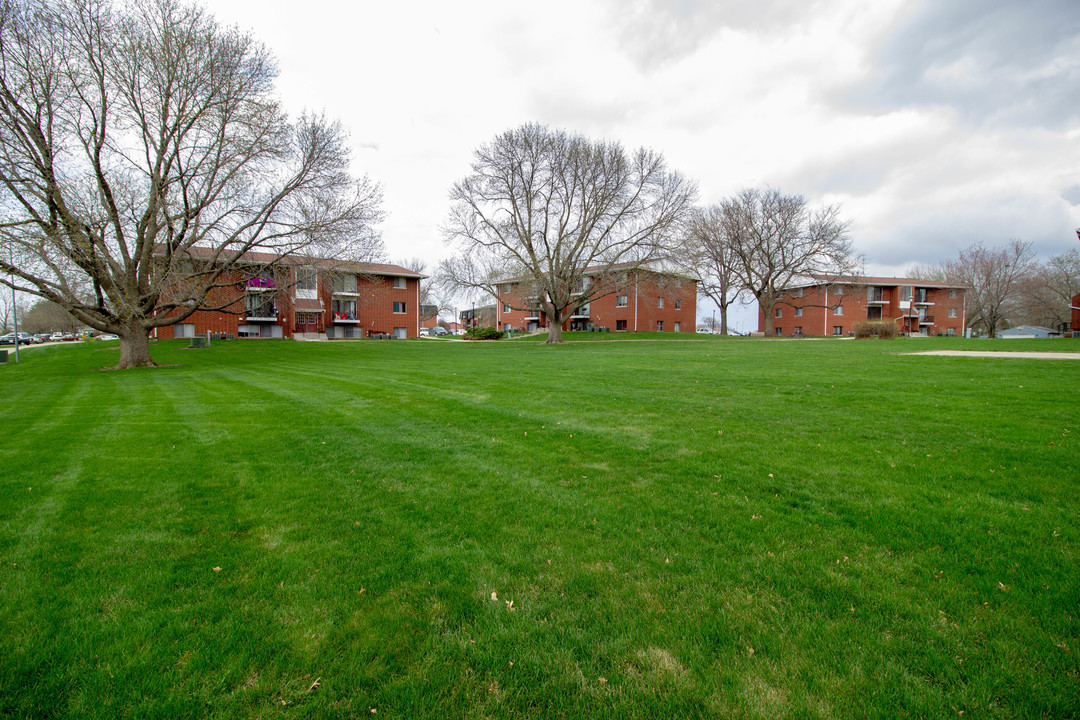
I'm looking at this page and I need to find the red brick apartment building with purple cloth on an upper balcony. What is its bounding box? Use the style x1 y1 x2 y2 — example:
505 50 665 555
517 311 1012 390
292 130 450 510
157 253 426 339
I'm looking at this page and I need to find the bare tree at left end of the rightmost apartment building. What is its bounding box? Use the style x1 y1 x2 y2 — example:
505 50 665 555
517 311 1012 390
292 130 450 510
718 189 858 335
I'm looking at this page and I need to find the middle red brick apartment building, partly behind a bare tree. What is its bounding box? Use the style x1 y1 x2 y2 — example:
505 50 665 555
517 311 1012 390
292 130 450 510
495 268 698 332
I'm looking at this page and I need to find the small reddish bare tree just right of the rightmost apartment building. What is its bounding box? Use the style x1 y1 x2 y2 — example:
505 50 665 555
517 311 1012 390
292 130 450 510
945 240 1035 338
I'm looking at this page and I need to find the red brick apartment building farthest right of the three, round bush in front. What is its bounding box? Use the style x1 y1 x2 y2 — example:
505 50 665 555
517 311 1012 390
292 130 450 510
757 277 966 337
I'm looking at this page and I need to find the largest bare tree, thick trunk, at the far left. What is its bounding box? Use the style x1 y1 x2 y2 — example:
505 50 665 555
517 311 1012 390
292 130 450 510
0 0 381 368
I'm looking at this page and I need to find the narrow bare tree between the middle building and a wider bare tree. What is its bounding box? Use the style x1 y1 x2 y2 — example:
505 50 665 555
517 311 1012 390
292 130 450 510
679 205 744 335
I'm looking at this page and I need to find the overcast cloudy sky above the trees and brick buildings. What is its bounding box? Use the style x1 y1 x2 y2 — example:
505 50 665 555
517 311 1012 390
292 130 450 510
207 0 1080 321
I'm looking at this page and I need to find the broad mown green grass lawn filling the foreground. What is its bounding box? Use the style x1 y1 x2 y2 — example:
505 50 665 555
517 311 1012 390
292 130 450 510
0 334 1080 719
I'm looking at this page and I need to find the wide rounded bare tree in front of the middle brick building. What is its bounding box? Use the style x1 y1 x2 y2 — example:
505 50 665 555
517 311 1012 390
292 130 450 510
438 124 696 343
